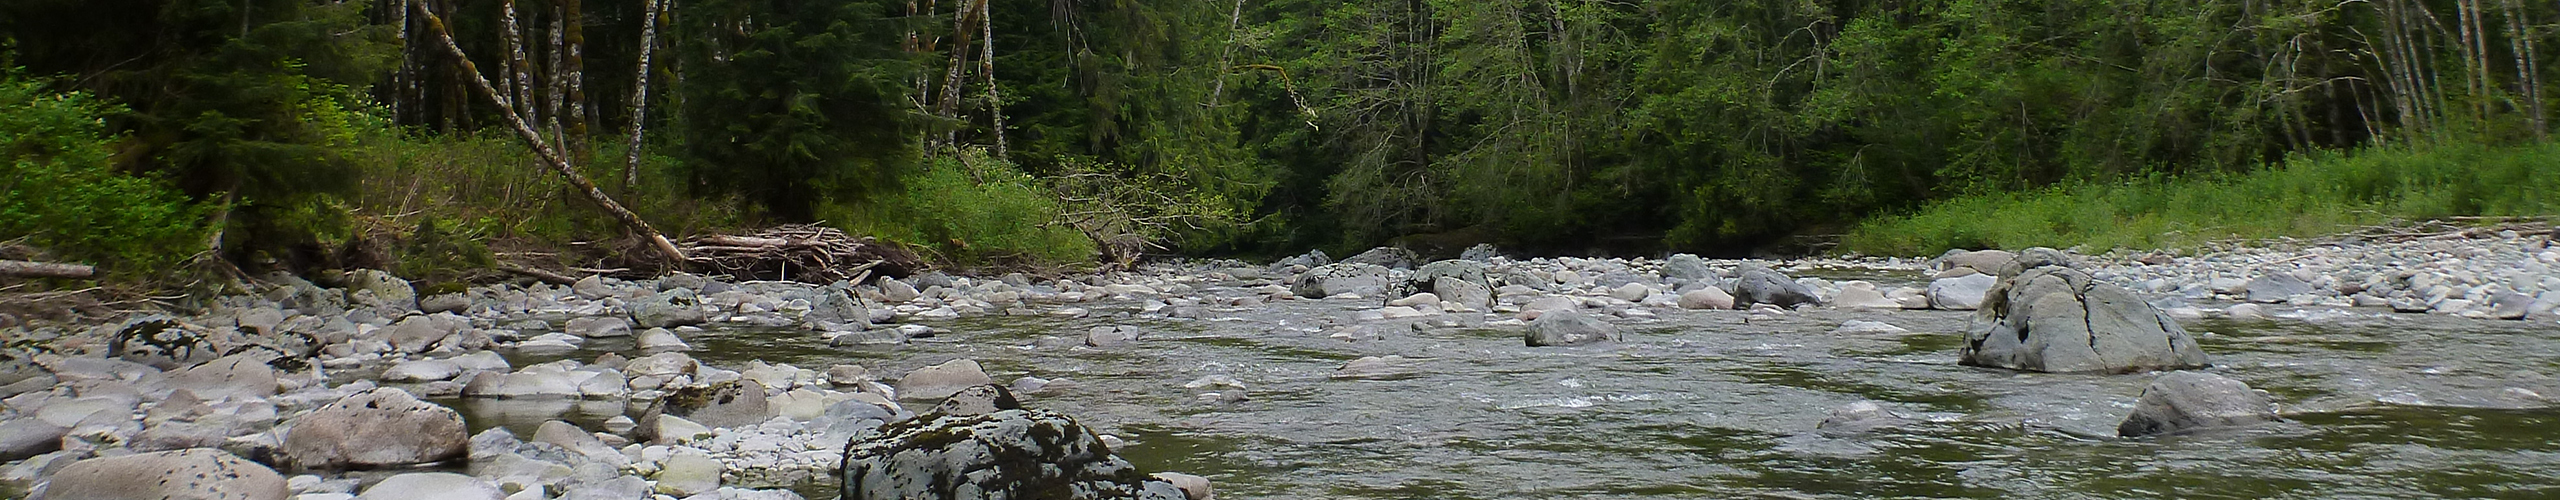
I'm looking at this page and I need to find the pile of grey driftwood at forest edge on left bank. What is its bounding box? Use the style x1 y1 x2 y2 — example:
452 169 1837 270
684 226 924 285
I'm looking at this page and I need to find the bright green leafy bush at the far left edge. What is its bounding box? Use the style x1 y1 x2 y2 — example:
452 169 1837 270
0 69 205 277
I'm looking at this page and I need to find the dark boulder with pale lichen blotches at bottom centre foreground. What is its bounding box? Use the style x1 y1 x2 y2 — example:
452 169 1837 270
842 410 1188 500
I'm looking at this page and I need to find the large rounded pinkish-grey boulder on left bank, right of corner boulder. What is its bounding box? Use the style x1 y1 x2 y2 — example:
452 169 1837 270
284 387 471 469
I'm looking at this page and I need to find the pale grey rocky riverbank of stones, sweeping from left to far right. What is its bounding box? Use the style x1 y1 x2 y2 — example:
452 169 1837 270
0 236 2560 500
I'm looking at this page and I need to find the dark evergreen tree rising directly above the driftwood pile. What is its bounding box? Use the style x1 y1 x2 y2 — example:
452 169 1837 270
673 0 916 221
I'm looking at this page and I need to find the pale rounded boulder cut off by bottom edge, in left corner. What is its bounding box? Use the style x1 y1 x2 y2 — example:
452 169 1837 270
28 449 287 500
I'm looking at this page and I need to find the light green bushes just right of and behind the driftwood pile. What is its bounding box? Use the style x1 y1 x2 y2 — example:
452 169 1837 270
827 149 1093 267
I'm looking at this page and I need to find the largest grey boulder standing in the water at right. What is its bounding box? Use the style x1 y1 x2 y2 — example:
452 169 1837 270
1958 267 2207 372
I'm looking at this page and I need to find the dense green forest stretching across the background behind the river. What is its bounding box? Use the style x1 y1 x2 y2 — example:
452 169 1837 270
0 0 2560 273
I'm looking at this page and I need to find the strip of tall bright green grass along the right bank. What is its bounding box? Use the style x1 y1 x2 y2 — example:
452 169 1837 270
1841 144 2560 256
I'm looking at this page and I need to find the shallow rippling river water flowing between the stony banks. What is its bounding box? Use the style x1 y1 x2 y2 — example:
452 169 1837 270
461 277 2560 500
